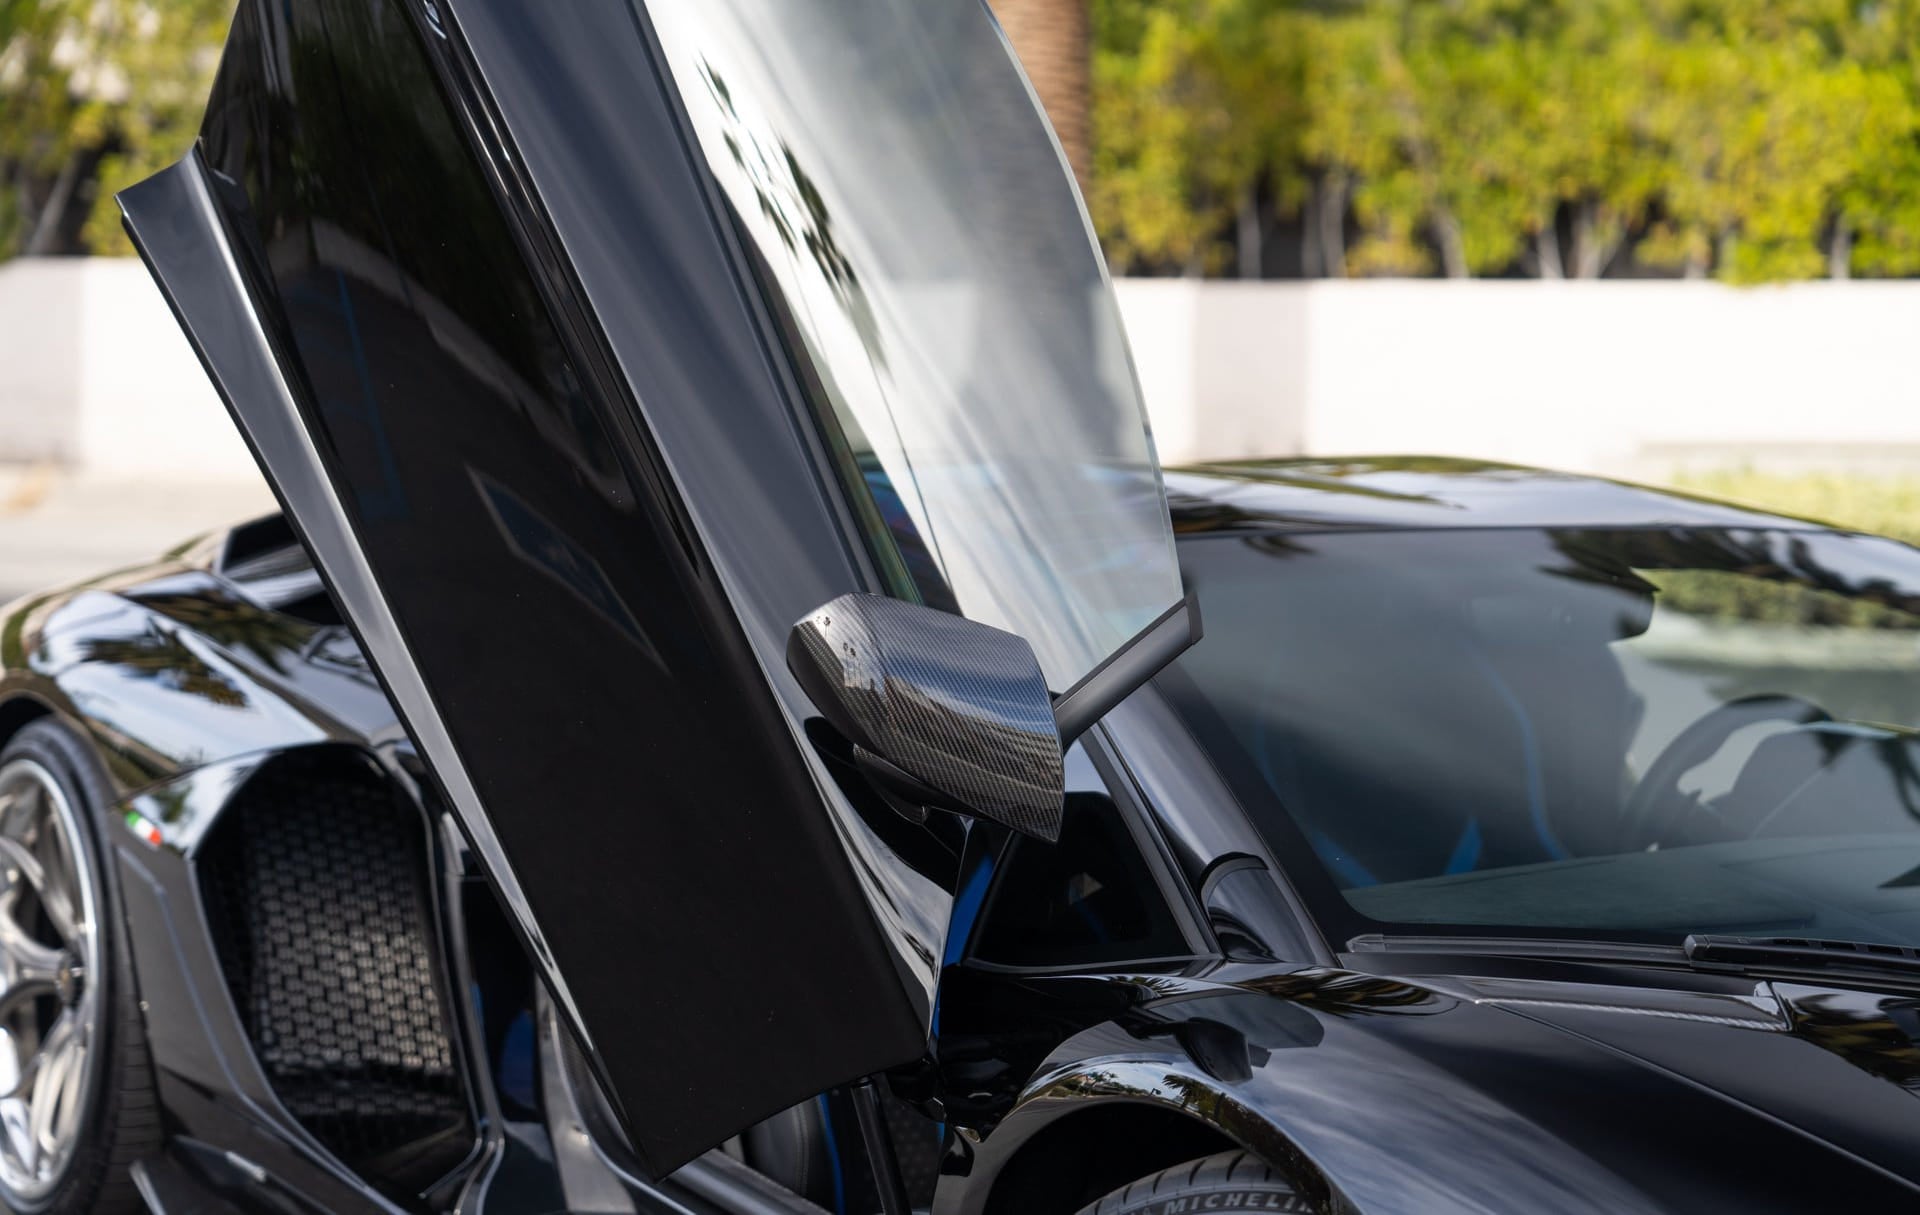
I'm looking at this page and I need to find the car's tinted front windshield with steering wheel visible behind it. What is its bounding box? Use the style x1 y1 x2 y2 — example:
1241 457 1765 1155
1164 528 1920 944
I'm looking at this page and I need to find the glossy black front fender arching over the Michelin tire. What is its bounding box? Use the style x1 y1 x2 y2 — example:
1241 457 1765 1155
943 965 1916 1215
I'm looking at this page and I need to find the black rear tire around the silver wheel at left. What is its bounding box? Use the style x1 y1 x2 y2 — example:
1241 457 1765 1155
0 718 161 1215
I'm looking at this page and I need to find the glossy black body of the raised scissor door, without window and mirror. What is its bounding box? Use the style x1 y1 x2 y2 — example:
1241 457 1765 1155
127 0 947 1173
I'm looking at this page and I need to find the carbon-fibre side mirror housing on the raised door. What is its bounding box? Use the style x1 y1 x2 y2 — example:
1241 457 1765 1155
787 595 1066 843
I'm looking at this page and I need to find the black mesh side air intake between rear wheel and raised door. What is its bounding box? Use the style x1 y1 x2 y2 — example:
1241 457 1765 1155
198 752 472 1196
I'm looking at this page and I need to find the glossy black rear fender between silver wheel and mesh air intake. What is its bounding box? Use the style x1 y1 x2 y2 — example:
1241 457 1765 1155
0 537 439 1211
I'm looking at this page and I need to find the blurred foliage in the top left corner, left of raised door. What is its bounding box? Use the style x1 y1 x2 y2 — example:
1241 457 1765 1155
0 0 232 257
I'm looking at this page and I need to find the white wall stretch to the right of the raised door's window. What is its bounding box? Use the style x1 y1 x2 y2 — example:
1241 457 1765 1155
1119 280 1920 474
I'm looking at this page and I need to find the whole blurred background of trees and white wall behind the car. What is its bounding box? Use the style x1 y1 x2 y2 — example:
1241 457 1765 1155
0 0 1920 597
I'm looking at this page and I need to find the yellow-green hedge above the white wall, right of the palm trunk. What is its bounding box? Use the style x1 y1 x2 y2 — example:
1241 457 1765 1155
1092 0 1920 282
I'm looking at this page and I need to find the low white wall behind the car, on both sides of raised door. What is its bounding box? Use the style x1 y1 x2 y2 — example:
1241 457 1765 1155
0 259 1920 482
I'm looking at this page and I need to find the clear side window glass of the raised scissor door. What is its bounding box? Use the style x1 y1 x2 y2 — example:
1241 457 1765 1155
647 0 1181 691
